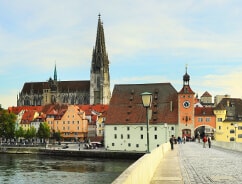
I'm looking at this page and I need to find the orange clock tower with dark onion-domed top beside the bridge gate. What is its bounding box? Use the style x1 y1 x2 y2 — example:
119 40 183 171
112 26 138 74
178 66 195 137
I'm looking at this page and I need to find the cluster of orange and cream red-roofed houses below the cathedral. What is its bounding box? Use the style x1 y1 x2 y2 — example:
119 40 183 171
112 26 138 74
8 104 108 142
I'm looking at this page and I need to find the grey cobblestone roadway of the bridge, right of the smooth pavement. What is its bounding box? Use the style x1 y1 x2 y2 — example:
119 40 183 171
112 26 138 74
179 142 242 184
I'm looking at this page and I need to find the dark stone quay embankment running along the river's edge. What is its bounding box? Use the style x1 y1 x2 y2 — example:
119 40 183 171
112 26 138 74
0 146 145 160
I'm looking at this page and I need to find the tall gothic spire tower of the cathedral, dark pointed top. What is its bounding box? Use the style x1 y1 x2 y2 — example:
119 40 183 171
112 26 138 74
90 14 111 105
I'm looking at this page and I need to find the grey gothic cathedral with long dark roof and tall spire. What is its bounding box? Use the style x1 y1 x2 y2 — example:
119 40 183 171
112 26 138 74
17 14 111 106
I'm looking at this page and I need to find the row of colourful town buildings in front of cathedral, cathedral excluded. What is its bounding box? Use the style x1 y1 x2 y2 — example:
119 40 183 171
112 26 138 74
8 69 242 151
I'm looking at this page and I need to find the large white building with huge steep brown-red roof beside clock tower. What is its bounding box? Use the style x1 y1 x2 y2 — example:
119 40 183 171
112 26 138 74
104 83 178 151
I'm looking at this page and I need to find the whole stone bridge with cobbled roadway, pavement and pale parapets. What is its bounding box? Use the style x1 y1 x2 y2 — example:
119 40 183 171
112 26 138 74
113 141 242 184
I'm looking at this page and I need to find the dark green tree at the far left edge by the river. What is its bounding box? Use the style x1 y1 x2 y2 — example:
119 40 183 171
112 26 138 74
0 110 17 139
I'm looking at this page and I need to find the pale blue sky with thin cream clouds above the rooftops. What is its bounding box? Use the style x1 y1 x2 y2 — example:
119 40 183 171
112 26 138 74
0 0 242 108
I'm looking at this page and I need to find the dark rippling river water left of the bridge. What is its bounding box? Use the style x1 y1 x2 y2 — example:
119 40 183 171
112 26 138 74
0 154 134 184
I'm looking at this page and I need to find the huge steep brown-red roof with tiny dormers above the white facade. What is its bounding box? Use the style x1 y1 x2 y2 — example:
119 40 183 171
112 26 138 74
105 83 178 124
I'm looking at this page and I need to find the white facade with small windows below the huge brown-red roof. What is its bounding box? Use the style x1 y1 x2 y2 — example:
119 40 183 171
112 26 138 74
104 124 177 152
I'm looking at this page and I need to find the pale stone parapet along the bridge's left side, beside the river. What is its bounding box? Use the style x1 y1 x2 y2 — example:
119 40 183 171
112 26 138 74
113 143 170 184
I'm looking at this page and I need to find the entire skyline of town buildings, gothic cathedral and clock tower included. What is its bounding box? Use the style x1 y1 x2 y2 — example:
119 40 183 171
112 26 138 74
5 15 242 151
